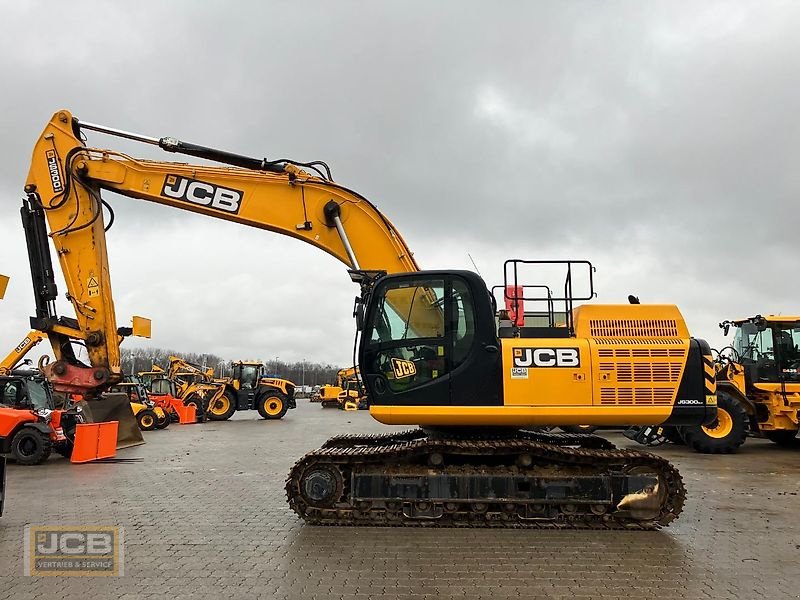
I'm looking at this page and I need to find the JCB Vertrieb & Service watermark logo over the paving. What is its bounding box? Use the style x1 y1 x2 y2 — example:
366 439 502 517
25 525 125 577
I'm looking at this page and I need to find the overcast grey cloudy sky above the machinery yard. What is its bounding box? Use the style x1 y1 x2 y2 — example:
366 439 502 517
0 0 800 364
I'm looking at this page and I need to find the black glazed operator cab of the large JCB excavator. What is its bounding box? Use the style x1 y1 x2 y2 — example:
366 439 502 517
360 271 503 406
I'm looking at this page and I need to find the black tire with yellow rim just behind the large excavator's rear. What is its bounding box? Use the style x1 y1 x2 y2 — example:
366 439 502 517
680 391 748 454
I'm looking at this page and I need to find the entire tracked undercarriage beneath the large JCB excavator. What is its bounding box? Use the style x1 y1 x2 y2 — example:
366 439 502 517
286 429 685 529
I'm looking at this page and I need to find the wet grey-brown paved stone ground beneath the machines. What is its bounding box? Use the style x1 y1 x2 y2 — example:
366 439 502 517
0 400 800 600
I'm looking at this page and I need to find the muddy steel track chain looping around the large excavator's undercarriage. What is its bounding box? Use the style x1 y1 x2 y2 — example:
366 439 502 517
286 430 686 530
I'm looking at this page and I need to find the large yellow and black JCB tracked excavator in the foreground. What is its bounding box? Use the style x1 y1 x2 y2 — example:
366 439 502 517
24 110 716 529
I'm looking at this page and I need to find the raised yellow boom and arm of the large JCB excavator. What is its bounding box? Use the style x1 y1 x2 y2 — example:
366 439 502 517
25 110 418 392
